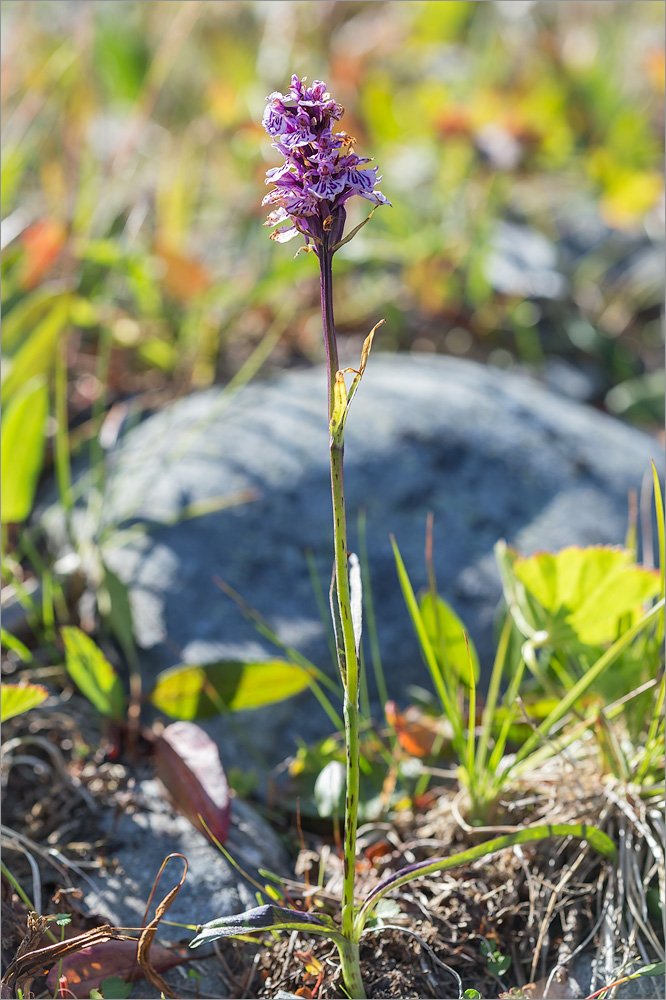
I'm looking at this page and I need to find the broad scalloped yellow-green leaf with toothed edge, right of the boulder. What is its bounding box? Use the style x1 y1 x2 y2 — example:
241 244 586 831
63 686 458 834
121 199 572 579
513 546 659 646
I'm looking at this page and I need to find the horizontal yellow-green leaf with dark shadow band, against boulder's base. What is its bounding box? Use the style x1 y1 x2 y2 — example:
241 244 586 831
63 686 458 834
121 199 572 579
150 660 309 719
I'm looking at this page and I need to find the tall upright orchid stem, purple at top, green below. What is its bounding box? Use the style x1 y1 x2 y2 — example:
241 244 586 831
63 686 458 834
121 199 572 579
319 245 364 960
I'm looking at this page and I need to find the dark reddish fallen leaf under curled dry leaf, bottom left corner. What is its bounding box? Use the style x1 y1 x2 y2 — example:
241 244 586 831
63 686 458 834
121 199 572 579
46 941 188 997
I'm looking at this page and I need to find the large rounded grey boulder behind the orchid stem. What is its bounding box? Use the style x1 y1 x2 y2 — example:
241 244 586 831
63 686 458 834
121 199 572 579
55 355 661 765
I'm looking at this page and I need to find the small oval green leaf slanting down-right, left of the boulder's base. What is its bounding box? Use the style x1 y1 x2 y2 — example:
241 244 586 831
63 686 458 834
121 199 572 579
61 625 125 721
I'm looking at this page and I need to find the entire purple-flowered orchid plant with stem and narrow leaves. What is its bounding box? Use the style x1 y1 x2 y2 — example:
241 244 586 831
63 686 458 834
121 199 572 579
191 76 615 998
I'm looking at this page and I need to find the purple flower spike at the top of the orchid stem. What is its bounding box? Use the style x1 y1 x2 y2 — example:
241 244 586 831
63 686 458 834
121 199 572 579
262 75 391 253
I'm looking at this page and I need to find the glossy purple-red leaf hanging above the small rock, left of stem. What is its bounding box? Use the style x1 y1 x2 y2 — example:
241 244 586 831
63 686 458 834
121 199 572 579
155 722 231 844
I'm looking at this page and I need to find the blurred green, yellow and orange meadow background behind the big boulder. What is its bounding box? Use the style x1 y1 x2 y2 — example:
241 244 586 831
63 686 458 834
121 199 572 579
2 0 664 438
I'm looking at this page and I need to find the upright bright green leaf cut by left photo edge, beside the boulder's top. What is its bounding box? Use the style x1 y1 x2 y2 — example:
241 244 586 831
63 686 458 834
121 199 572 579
0 378 49 524
